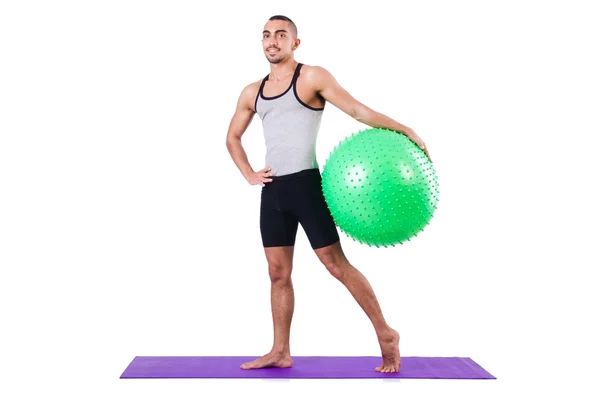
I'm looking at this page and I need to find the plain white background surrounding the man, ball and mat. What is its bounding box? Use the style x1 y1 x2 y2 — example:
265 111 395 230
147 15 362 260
0 0 600 396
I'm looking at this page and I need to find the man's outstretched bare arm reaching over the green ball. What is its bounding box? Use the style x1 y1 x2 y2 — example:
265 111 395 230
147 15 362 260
310 66 431 160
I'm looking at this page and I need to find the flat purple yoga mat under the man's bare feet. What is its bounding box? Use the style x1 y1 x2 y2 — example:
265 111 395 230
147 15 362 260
121 356 496 379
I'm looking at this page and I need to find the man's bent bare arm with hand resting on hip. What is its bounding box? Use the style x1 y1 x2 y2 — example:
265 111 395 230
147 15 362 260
226 83 271 186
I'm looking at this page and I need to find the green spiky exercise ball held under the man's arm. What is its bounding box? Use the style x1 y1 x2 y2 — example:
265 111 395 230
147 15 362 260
321 128 439 247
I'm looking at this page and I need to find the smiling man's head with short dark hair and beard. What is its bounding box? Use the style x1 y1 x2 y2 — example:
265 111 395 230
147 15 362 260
262 15 300 63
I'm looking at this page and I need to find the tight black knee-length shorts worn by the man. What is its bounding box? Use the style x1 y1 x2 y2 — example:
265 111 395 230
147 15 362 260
260 168 340 249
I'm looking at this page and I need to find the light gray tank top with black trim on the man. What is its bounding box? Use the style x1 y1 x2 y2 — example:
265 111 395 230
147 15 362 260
254 63 325 176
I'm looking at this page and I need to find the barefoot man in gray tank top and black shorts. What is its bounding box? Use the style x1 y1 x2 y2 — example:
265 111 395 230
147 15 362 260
227 15 428 372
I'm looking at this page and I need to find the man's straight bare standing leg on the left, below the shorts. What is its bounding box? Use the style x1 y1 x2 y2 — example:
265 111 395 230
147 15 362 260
241 246 294 369
